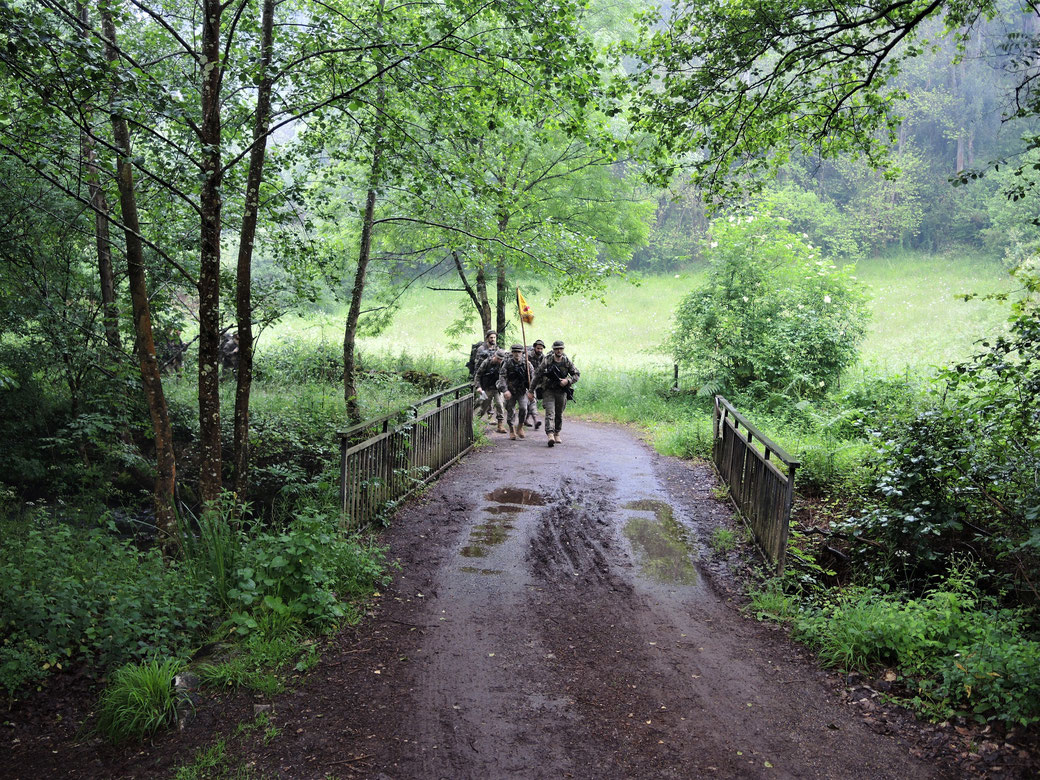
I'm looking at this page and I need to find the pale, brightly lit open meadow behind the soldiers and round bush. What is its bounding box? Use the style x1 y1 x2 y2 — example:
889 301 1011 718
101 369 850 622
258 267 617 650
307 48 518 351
260 254 1011 380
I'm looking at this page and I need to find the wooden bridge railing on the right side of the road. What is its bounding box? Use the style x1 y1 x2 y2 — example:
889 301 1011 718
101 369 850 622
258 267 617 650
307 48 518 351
711 395 799 574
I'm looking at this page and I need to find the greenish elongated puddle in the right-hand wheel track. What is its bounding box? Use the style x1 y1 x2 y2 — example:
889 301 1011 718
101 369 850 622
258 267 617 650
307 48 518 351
622 498 697 586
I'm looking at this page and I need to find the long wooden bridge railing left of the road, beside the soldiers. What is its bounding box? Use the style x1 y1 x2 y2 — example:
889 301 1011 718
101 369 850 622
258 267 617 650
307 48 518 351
339 383 473 529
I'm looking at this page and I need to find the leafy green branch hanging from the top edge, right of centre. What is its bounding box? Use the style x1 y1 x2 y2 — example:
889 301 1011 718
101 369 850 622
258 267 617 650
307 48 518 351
626 0 995 200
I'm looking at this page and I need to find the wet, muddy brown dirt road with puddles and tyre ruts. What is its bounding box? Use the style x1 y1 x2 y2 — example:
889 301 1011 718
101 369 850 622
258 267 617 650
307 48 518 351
250 422 935 778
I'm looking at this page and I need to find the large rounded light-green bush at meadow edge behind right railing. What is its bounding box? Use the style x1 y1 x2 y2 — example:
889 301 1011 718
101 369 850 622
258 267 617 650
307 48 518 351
669 209 866 397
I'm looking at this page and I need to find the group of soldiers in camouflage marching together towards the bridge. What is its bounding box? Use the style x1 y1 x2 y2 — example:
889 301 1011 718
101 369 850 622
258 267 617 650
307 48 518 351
468 331 581 447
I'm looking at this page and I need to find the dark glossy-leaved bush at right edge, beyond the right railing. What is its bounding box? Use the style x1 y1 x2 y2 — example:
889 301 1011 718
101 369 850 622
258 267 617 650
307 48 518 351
846 272 1040 590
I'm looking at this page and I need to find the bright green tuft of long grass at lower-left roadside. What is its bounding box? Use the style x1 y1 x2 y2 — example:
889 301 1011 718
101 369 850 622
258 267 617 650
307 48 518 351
98 658 183 743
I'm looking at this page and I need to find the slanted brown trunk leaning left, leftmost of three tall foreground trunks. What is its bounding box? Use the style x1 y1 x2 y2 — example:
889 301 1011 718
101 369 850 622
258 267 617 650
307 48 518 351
100 3 180 548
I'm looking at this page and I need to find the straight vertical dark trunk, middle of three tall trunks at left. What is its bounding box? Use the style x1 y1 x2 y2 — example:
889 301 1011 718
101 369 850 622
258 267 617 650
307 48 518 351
199 0 225 505
